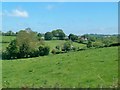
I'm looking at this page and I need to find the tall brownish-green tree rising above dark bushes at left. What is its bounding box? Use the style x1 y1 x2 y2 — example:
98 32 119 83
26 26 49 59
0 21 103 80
16 29 38 58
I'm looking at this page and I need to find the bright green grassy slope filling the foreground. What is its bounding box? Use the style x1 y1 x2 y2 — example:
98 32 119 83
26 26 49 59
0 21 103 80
2 47 118 87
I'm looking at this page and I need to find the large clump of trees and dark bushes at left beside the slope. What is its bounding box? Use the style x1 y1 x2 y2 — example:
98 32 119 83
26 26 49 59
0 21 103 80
2 30 50 59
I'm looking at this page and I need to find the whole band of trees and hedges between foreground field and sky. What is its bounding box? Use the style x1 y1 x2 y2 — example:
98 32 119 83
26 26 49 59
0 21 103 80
1 28 120 59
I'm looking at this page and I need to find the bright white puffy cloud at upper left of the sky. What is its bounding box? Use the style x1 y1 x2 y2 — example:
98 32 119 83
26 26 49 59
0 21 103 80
3 9 29 18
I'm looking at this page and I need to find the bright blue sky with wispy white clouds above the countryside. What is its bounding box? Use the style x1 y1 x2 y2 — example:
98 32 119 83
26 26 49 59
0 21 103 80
1 2 118 35
